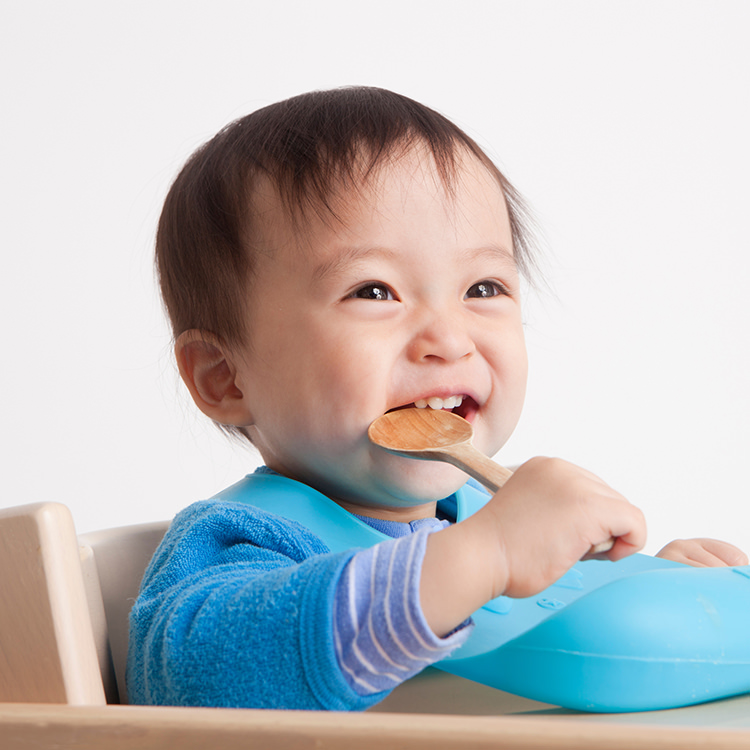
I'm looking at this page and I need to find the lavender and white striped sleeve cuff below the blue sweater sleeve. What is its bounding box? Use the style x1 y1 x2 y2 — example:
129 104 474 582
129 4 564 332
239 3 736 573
334 528 471 695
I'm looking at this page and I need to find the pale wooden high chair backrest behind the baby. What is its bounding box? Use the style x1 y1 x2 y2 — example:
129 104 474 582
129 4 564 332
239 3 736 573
0 503 167 705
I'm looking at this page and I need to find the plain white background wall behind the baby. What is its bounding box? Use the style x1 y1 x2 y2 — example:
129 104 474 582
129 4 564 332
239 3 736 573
0 0 750 552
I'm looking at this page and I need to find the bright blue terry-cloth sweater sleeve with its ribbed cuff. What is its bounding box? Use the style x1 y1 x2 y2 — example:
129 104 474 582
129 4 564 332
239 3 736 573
127 500 386 710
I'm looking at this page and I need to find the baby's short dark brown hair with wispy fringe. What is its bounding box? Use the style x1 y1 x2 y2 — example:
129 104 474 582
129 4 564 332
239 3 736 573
156 87 533 345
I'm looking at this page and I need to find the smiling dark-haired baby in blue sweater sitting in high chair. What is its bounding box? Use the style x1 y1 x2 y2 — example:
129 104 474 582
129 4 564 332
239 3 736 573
128 88 747 710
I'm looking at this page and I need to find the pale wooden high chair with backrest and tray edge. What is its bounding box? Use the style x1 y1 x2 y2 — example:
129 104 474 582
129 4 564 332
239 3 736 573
0 503 750 750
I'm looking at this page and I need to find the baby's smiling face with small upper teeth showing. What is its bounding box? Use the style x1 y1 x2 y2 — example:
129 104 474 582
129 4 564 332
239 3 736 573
236 153 527 519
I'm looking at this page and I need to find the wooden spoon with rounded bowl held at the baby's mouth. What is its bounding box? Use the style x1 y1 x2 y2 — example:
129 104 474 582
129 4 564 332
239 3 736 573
367 408 615 558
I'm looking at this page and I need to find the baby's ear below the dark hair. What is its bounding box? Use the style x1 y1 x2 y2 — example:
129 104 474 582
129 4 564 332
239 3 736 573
175 330 253 427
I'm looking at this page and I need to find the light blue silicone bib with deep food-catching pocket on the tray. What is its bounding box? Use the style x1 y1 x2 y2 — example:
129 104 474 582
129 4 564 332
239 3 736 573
217 474 750 712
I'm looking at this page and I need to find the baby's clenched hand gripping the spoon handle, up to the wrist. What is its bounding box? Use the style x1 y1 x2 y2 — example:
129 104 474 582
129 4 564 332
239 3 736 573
485 458 646 597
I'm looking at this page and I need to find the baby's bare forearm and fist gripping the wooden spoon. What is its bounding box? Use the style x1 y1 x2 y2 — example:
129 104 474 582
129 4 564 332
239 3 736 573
420 458 646 635
